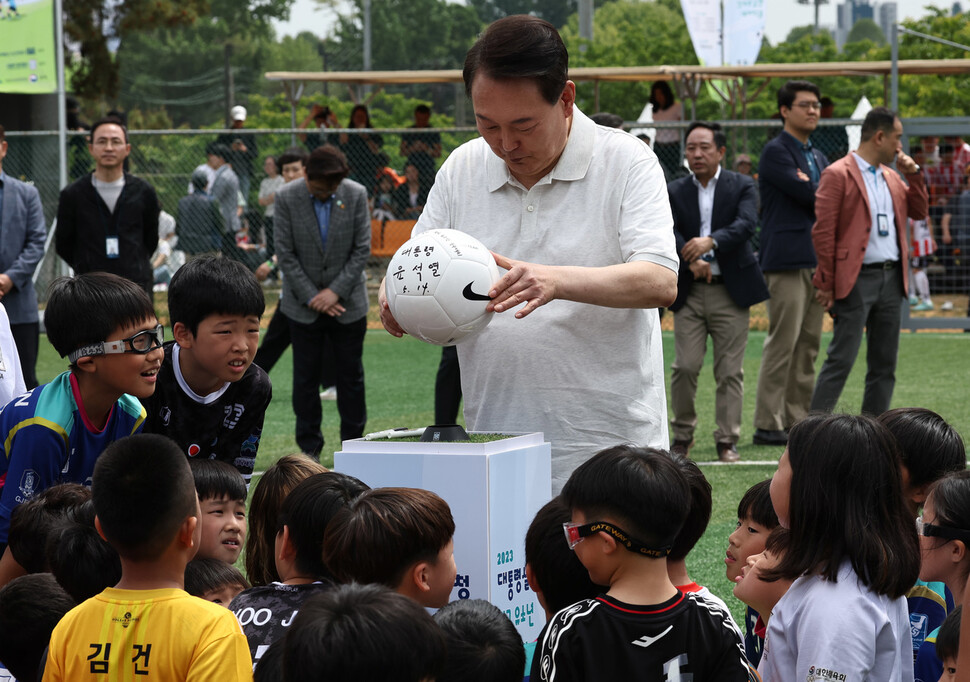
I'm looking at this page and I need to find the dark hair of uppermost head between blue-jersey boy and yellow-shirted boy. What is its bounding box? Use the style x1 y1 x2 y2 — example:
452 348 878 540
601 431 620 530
9 483 91 573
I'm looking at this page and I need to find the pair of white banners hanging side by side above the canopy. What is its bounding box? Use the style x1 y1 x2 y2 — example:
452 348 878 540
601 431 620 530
680 0 765 66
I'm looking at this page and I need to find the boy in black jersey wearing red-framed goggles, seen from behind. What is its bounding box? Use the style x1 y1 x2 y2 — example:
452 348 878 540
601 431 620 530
530 445 758 682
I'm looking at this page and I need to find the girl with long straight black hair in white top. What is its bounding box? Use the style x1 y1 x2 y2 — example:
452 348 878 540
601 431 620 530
758 414 920 682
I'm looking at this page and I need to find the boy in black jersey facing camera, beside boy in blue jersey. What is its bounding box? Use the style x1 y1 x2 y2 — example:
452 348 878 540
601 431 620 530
143 257 272 485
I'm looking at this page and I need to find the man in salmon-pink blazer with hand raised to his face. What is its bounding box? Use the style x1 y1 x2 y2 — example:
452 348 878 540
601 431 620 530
811 107 927 415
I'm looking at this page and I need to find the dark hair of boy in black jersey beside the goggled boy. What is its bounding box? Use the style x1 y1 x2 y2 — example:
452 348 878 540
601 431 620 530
168 256 266 335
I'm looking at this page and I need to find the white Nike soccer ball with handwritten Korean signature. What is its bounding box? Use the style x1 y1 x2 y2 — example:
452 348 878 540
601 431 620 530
384 230 501 346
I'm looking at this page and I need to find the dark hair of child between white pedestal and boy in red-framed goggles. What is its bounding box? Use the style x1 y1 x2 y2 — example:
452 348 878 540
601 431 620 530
525 495 604 613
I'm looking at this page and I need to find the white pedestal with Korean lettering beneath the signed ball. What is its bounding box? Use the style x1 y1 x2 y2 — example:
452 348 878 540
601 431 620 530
333 433 552 642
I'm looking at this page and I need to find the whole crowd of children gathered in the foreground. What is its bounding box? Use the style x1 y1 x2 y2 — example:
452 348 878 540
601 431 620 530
0 247 970 682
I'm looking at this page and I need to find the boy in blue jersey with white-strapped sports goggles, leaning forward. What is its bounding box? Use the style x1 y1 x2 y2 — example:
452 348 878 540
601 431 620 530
0 272 162 564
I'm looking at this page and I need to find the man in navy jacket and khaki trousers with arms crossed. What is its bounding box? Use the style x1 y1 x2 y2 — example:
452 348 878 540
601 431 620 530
754 81 828 445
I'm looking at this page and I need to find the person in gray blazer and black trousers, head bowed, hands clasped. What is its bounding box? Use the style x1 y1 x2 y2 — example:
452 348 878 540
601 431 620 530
274 145 370 457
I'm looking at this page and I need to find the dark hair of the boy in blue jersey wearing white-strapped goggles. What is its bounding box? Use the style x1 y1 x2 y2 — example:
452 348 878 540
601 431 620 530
44 272 155 368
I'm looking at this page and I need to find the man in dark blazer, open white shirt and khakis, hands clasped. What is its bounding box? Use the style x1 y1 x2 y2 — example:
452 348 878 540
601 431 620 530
667 121 768 462
